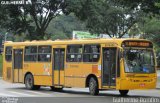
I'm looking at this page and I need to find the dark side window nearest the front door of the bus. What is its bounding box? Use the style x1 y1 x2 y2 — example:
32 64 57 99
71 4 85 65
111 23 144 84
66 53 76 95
83 44 100 62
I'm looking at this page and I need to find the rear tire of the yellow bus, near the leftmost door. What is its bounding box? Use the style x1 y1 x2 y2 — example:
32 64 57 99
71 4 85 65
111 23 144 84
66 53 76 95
25 74 40 90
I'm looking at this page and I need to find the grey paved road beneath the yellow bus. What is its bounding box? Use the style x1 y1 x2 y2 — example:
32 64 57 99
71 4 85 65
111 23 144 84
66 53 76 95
0 79 160 103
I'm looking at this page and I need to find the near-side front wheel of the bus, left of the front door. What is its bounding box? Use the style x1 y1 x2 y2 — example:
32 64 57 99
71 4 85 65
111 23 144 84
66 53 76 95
89 77 99 95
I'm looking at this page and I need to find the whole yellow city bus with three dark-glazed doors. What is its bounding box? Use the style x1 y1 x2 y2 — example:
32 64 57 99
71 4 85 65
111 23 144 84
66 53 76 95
3 38 157 95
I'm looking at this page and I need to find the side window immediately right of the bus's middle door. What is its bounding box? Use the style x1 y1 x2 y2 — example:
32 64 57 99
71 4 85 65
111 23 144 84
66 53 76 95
66 45 82 62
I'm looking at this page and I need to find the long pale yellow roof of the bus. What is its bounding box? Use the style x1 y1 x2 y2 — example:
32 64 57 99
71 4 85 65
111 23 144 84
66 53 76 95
4 38 151 46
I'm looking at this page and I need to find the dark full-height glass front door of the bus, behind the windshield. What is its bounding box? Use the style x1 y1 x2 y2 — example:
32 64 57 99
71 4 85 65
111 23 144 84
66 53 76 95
102 48 117 87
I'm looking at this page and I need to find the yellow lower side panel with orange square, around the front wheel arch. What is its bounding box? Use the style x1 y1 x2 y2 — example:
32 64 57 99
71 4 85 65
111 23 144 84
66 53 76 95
65 62 101 88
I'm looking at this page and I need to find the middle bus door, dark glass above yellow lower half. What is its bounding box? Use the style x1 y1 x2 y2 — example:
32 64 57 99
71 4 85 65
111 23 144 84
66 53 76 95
52 48 65 86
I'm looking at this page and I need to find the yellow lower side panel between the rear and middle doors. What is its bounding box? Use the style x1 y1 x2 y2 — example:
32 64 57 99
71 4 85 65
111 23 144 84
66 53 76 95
23 62 52 85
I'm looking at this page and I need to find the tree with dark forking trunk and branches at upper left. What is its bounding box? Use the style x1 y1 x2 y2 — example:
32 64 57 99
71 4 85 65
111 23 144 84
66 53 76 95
0 0 66 39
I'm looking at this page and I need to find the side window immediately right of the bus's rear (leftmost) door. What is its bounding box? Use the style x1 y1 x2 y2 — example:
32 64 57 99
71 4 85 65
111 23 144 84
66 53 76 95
24 46 37 61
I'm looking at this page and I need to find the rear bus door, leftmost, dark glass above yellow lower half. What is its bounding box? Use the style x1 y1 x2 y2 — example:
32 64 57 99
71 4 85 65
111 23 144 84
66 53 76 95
13 49 23 83
